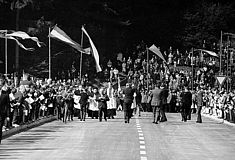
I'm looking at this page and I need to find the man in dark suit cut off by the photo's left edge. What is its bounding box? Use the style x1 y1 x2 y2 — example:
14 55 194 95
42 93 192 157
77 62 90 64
0 74 10 144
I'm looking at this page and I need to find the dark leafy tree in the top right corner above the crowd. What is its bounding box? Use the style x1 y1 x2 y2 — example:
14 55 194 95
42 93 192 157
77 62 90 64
177 0 235 49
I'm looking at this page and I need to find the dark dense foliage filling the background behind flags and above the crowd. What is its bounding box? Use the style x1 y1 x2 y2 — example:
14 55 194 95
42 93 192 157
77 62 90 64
0 0 235 77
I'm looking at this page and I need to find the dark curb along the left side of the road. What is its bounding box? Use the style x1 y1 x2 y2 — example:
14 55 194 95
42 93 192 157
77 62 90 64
2 116 57 139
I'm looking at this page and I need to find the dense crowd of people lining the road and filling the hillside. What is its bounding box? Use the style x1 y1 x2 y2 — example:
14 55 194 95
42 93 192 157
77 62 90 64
0 41 235 144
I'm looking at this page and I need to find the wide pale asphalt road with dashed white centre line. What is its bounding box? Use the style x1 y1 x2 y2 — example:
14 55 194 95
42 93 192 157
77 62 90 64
0 112 235 160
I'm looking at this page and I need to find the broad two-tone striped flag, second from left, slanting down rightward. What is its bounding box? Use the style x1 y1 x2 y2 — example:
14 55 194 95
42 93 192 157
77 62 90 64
49 25 85 53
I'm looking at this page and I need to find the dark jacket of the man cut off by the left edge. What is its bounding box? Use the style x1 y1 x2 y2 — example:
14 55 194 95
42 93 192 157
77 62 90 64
0 93 10 117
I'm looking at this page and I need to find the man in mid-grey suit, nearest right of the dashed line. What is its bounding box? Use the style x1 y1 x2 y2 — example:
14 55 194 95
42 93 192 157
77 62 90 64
151 84 162 124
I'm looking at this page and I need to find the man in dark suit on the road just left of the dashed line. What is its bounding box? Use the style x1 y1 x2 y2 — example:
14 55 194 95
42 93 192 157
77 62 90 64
123 83 135 123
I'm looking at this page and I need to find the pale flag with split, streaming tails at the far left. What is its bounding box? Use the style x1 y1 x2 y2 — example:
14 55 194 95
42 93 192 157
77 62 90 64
0 30 42 51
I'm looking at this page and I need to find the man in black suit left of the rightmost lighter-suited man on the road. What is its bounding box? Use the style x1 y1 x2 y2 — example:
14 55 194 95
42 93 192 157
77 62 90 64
180 86 192 122
